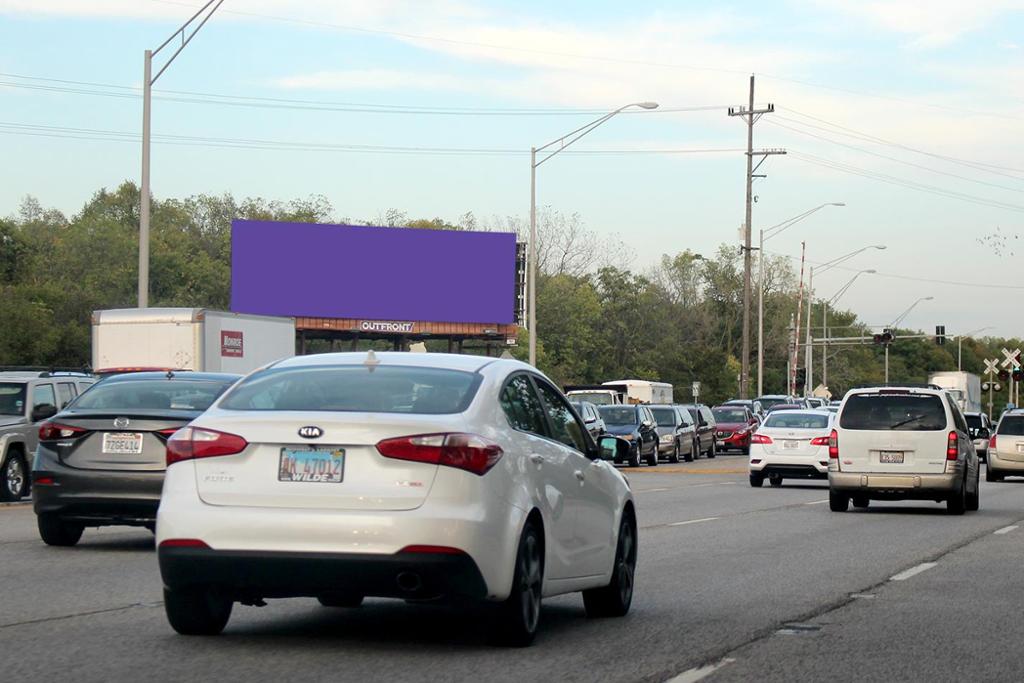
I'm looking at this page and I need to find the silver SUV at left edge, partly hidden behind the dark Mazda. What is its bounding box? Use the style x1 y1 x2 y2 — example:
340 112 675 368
0 370 95 501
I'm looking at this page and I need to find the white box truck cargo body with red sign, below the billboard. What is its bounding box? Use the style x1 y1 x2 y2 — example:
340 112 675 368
92 308 295 374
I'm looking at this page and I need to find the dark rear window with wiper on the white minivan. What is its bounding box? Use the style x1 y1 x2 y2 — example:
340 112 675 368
840 393 946 431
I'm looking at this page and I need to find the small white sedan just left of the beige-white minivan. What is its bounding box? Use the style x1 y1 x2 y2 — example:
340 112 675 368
750 410 835 488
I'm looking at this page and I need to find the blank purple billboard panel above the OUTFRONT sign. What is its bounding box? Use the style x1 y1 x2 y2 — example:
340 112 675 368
231 220 516 323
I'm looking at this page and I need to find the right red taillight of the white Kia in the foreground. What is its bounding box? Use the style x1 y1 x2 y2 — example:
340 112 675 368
377 433 505 476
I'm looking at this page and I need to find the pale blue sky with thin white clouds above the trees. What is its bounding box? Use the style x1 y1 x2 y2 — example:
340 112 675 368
0 0 1024 336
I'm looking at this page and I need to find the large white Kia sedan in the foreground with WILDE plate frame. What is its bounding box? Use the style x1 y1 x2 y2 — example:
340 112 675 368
157 352 637 645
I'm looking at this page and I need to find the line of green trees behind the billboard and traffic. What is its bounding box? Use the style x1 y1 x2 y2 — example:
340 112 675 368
0 182 1022 408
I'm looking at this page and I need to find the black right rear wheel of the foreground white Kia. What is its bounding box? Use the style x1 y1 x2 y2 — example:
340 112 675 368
494 521 544 647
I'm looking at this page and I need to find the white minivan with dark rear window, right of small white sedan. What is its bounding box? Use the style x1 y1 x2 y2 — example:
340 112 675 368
828 385 980 514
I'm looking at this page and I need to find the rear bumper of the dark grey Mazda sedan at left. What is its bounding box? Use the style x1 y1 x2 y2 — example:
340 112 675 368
32 460 164 526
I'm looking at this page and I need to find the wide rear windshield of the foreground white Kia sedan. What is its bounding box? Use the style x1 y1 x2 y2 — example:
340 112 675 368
218 365 481 415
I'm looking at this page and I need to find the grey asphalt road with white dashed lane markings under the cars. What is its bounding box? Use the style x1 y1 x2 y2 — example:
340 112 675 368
0 456 1024 683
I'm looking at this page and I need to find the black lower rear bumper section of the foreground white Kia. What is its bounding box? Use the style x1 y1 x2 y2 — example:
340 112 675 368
157 546 487 600
